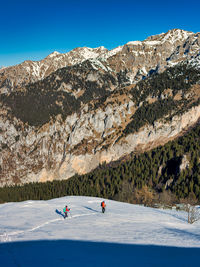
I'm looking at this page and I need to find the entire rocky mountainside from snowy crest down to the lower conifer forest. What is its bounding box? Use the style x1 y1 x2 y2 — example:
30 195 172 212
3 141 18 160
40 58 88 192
0 30 200 186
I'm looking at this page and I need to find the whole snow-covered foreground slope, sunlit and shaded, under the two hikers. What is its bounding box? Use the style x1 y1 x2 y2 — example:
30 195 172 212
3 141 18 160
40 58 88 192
0 196 200 267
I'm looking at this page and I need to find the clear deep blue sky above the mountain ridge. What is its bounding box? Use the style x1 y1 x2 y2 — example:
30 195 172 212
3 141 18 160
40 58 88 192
0 0 200 66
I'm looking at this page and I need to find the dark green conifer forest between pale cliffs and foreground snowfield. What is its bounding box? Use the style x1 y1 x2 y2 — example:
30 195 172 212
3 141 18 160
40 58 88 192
0 124 200 205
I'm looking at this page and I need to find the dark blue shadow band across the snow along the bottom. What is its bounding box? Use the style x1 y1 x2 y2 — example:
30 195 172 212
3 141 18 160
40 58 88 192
0 240 200 267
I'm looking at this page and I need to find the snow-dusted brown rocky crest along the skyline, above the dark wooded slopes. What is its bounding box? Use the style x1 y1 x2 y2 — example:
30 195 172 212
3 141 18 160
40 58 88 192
0 29 200 93
